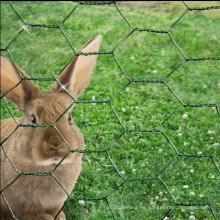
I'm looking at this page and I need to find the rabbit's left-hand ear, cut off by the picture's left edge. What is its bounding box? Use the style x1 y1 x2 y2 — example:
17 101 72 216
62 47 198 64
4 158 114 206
1 55 39 111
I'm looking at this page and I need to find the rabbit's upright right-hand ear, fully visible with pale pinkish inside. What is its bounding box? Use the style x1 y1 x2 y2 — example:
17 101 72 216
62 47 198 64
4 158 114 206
56 35 102 99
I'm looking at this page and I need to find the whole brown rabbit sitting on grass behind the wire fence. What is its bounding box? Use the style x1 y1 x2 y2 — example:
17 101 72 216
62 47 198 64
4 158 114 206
0 35 102 220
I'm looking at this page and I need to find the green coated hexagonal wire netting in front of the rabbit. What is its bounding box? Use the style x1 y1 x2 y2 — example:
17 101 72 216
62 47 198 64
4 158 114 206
0 1 220 219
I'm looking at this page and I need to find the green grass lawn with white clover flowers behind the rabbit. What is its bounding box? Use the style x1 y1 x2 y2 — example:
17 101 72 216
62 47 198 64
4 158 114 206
1 1 220 220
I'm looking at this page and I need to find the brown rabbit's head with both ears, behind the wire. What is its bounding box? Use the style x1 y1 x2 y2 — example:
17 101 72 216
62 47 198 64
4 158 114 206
1 35 102 166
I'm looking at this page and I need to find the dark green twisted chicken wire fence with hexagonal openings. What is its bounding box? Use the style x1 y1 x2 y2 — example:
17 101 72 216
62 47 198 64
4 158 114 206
0 1 220 219
